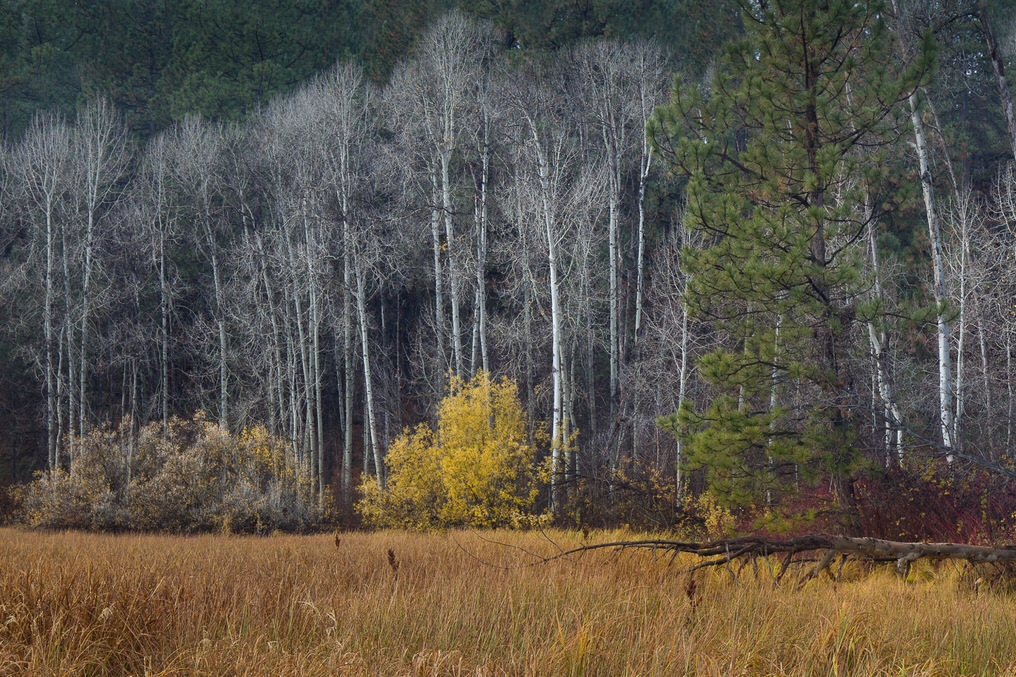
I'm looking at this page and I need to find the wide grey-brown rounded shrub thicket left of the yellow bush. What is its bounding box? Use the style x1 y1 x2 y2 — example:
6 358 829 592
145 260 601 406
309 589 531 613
23 414 322 533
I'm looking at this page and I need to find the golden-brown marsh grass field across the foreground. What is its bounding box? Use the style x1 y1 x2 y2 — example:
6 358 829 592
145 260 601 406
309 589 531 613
0 530 1016 676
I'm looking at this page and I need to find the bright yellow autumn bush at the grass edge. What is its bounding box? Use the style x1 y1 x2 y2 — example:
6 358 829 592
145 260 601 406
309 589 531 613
358 371 537 530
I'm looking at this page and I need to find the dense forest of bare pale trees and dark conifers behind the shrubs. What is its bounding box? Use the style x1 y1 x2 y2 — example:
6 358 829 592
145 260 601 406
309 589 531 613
0 0 1016 536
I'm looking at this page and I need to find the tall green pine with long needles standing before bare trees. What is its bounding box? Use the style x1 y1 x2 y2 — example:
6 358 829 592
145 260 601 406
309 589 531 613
651 0 931 518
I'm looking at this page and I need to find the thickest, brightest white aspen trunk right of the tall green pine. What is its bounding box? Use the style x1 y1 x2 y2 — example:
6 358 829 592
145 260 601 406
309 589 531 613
908 94 954 463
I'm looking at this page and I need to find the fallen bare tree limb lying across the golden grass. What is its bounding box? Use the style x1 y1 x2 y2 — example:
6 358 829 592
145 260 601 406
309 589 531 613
547 534 1016 584
